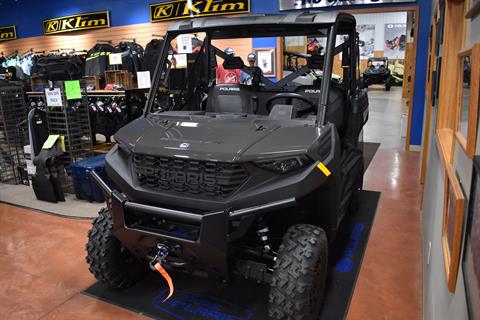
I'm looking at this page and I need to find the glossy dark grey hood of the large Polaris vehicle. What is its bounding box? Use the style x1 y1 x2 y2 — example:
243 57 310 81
115 116 320 162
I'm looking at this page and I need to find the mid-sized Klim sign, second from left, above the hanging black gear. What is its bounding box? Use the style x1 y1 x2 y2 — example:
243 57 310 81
43 11 110 35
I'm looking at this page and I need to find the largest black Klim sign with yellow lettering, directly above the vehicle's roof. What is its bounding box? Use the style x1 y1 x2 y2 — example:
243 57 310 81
150 0 250 22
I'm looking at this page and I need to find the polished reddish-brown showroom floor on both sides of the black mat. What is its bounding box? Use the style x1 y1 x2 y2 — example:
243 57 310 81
0 87 422 320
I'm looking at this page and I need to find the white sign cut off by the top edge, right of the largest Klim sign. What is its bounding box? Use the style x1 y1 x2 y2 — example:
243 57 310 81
278 0 416 10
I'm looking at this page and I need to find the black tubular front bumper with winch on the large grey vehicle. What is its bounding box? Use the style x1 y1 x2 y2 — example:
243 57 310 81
91 171 296 281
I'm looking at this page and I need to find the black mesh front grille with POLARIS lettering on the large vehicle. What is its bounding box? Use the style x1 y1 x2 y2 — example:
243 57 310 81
133 154 248 197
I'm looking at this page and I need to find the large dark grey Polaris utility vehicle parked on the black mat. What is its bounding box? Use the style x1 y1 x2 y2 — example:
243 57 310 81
87 12 368 320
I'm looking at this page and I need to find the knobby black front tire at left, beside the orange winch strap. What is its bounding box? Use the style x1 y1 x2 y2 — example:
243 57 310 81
86 208 147 289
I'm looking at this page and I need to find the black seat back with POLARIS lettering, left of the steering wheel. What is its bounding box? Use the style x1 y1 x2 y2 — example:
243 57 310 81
207 84 257 113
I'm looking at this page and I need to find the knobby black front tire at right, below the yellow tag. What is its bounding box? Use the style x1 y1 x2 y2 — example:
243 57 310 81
268 224 328 320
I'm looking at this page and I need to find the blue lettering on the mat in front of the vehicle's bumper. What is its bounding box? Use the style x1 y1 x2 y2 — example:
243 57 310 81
151 290 253 320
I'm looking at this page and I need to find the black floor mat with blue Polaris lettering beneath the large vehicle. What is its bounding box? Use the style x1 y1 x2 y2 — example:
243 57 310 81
84 191 380 320
